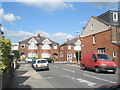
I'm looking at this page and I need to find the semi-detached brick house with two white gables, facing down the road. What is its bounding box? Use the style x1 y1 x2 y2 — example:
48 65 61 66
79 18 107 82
19 34 59 58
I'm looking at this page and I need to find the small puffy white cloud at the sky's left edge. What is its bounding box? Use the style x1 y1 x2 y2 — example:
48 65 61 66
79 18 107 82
0 9 21 24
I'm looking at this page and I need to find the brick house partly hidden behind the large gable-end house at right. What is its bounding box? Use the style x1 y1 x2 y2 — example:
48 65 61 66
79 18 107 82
59 36 81 61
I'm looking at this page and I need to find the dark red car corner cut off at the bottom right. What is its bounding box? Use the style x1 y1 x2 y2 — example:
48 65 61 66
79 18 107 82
95 83 120 90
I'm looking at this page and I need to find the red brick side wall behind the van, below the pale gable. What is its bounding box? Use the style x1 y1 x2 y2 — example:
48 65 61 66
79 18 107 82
81 30 120 67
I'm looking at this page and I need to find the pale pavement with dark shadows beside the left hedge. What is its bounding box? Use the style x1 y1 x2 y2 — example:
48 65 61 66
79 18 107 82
7 62 53 88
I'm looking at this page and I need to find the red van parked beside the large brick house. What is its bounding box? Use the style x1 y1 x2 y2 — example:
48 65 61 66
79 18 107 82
80 53 116 73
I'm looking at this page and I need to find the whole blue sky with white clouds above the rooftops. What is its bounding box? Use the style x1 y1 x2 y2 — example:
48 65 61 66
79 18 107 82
0 0 118 43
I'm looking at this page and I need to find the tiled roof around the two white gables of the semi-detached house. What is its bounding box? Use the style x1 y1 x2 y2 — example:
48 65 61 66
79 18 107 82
19 36 59 44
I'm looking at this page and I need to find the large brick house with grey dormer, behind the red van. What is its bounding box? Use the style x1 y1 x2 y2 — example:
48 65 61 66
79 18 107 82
81 10 120 67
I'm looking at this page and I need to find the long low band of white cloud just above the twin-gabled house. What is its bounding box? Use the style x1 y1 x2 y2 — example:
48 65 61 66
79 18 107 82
3 28 73 42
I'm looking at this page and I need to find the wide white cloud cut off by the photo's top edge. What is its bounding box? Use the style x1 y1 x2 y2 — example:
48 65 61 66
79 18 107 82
17 0 73 12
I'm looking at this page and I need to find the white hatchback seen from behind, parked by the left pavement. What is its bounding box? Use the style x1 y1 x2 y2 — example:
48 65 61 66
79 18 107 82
33 59 49 71
